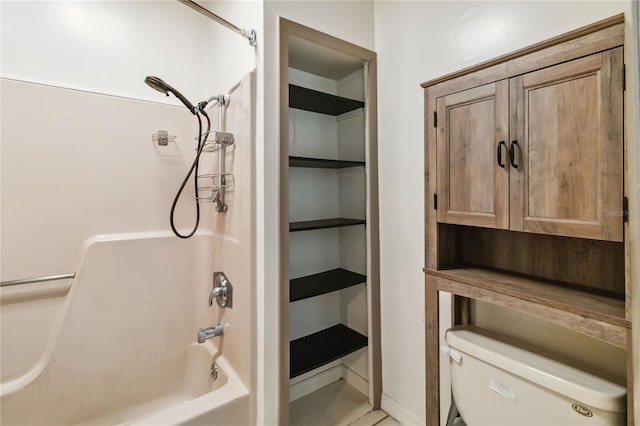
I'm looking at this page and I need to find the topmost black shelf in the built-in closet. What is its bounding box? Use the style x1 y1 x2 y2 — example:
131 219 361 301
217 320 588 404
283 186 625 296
289 84 364 116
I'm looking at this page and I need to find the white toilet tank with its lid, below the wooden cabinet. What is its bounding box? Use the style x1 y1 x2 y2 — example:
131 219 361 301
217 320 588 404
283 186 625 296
443 326 626 426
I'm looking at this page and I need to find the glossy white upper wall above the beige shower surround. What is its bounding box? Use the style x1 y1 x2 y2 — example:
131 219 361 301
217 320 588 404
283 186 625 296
1 0 262 105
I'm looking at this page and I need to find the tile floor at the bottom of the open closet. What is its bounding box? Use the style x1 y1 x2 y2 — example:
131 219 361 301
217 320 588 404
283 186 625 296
289 380 400 426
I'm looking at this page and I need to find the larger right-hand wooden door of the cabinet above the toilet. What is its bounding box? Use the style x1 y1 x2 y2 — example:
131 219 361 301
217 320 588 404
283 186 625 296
510 48 623 241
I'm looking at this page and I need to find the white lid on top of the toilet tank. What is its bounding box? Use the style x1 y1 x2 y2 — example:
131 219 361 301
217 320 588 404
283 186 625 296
445 326 627 411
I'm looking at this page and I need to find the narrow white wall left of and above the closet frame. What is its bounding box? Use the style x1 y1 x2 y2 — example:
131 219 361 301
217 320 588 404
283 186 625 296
256 1 374 425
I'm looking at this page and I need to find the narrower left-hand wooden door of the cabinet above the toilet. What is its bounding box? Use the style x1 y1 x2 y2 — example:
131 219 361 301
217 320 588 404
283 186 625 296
436 80 509 229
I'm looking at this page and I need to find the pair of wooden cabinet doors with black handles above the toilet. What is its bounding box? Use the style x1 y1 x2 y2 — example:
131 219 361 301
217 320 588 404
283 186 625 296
435 47 623 241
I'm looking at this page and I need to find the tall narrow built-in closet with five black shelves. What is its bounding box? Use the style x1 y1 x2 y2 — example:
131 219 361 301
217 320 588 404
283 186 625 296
281 21 379 406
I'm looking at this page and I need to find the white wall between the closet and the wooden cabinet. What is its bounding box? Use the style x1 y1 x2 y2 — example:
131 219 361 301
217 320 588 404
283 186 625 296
374 1 637 424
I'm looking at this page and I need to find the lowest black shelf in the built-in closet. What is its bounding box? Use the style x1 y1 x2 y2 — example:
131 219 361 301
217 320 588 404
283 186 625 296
289 324 368 378
